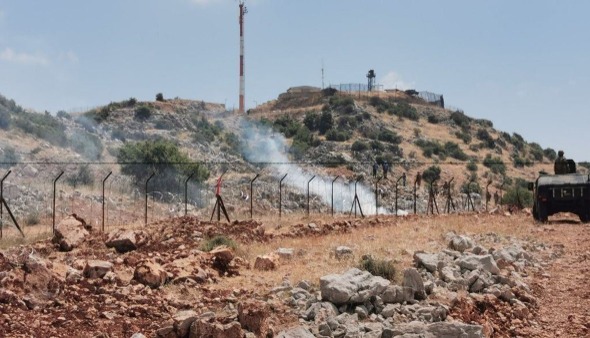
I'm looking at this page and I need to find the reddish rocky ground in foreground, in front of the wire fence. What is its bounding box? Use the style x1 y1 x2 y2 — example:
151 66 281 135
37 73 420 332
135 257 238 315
0 213 590 337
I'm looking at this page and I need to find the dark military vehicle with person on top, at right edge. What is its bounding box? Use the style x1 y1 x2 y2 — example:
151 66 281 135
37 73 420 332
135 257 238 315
529 160 590 223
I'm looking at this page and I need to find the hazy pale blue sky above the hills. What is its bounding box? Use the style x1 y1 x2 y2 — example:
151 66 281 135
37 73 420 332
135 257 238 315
0 0 590 161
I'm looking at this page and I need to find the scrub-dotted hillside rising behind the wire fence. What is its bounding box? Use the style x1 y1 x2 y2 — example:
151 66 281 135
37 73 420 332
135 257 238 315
0 87 586 228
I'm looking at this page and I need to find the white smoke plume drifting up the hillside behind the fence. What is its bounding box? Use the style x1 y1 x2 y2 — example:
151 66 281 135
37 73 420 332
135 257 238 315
240 119 390 216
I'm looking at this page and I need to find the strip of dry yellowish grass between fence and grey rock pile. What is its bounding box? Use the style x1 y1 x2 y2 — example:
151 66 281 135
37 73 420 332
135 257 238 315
209 213 537 289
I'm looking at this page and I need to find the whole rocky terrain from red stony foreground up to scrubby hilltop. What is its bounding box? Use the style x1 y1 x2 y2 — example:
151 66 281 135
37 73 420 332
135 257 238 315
0 90 590 338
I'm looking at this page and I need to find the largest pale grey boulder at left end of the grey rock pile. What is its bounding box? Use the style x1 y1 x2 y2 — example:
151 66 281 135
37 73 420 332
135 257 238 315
320 268 390 305
